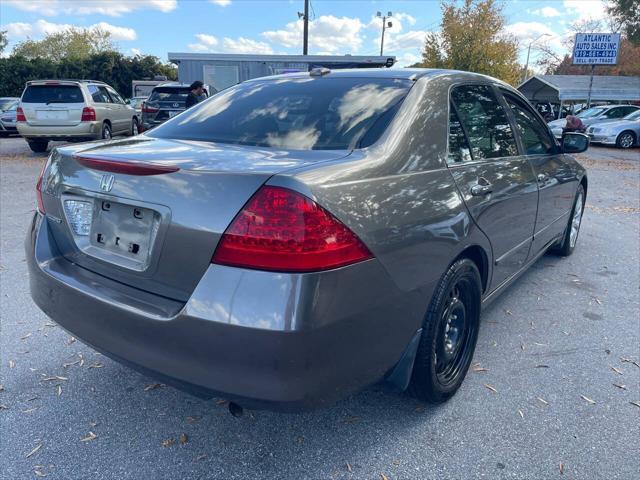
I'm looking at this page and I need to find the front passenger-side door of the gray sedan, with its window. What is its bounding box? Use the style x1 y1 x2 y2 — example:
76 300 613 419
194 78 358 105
500 89 577 255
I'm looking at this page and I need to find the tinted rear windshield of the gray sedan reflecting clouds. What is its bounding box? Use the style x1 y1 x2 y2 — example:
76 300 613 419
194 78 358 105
148 77 413 150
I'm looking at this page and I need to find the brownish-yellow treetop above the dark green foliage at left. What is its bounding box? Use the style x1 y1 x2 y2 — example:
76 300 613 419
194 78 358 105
13 27 116 61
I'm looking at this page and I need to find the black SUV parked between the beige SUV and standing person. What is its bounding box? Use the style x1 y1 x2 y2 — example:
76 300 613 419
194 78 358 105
142 82 209 130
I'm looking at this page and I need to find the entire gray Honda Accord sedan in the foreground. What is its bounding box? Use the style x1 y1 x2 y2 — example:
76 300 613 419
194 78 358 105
26 69 588 411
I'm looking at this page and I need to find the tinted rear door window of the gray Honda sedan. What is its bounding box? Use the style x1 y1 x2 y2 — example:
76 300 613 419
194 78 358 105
451 85 518 160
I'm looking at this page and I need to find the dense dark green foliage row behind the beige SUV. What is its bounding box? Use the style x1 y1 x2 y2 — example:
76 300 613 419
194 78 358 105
0 51 178 97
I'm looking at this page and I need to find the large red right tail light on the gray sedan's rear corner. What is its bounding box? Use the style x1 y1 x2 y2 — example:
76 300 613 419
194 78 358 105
212 186 373 272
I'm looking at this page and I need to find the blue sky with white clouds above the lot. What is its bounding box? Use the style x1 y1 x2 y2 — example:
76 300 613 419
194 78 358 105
0 0 604 66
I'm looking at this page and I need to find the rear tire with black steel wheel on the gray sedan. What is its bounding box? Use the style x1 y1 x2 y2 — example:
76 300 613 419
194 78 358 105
408 258 482 403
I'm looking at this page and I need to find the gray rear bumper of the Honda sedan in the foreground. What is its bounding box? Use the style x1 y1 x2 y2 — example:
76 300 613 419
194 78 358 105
26 214 426 411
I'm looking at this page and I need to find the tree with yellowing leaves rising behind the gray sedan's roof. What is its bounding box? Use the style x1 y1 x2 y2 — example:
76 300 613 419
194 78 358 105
417 0 520 85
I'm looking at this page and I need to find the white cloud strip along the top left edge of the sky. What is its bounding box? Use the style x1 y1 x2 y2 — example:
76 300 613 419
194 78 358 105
3 0 178 17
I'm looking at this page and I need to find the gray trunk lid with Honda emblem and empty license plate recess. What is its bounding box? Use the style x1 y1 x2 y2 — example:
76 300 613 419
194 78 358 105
42 136 348 301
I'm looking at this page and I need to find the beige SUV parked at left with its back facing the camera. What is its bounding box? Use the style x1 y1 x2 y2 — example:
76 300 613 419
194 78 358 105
17 80 139 152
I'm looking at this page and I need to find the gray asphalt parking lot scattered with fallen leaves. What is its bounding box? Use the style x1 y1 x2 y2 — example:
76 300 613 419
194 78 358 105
0 138 640 480
